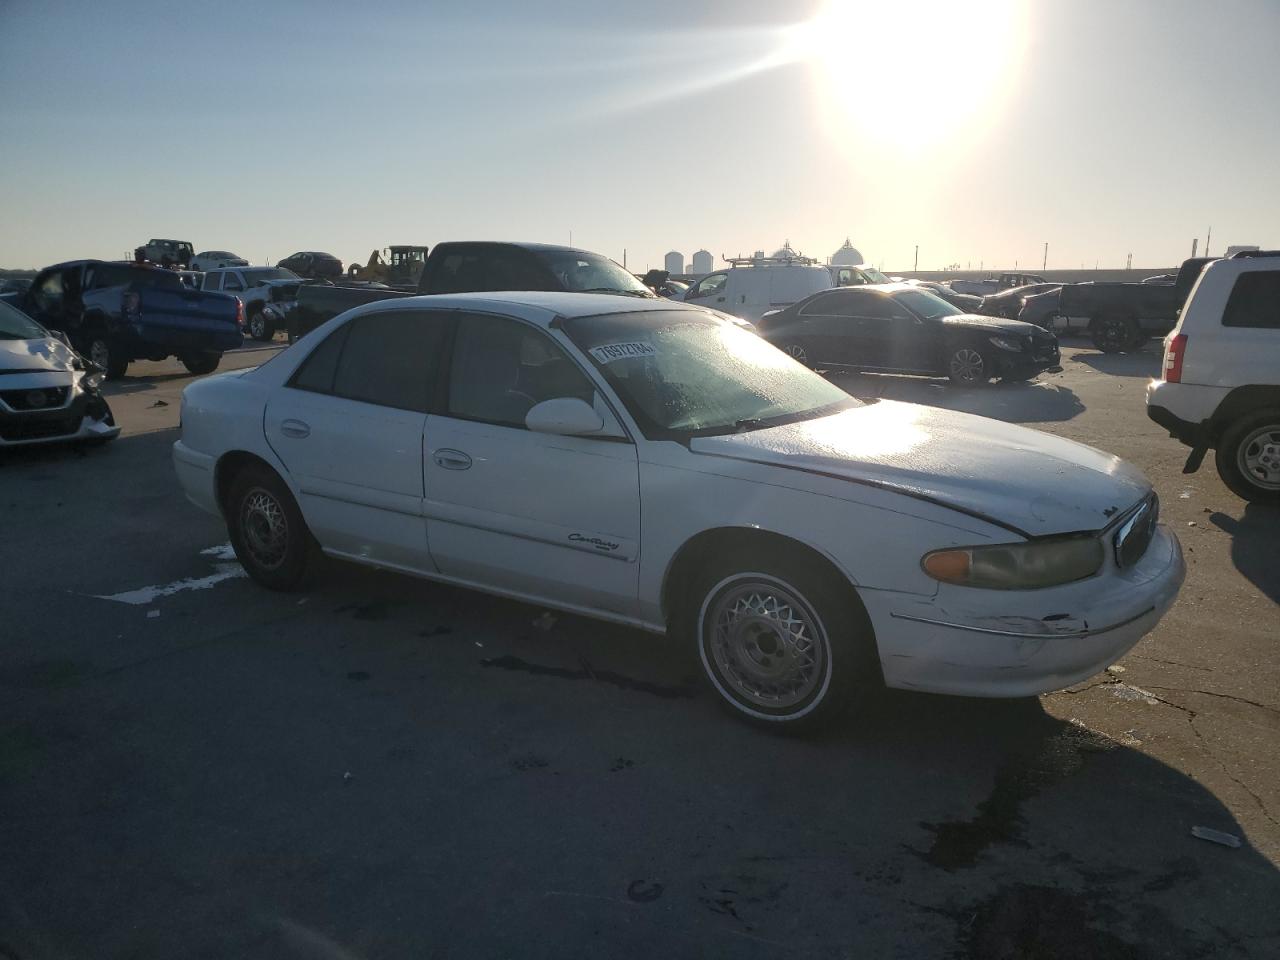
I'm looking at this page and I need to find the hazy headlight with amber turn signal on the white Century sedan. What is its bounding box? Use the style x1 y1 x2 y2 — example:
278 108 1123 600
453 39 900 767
920 536 1103 590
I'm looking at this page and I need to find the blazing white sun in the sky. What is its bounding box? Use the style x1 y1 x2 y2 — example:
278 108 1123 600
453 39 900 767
786 0 1027 146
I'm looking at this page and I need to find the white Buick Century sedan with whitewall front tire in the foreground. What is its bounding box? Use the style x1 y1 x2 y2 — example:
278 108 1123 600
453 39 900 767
174 293 1184 727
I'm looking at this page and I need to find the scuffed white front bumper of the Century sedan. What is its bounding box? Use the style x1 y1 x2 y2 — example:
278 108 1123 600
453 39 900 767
861 525 1187 696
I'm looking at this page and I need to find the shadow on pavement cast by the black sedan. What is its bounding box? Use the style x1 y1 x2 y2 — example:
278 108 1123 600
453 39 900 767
828 372 1084 424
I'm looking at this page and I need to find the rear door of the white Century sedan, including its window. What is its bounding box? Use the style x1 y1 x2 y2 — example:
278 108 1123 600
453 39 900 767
264 310 448 572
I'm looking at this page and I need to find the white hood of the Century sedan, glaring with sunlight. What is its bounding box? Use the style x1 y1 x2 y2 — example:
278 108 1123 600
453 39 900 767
690 401 1151 536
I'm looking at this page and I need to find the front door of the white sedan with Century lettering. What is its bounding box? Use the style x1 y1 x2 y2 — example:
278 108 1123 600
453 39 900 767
425 312 640 616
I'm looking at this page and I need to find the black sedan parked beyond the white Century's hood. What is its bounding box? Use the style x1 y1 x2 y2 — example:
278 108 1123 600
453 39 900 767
756 284 1060 385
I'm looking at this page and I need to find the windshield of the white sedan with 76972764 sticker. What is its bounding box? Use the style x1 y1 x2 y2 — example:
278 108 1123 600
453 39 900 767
564 310 858 440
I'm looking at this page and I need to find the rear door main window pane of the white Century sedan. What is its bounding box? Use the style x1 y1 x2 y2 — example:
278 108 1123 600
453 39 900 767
333 310 444 413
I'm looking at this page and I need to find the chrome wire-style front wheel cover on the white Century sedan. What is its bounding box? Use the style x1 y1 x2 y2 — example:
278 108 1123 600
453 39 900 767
701 576 831 713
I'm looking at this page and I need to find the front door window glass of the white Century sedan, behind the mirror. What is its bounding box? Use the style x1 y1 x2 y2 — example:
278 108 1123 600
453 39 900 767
447 314 595 429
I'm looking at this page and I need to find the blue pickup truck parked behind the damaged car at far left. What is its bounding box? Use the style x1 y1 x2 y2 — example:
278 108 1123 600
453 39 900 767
5 260 244 380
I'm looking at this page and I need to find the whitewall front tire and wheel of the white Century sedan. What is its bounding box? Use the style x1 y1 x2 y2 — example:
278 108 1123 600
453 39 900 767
686 549 883 732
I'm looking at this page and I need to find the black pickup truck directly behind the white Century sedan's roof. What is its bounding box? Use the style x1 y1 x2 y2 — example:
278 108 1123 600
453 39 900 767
284 241 654 343
